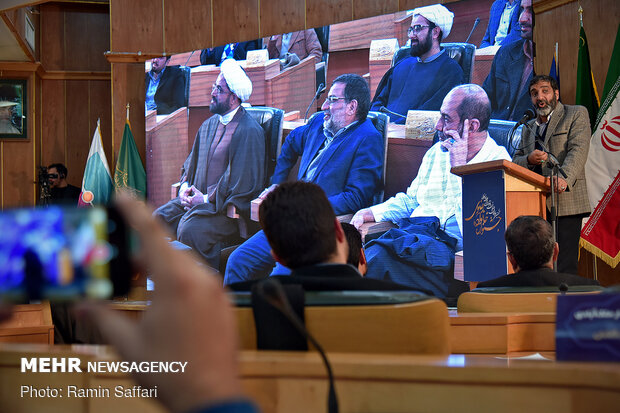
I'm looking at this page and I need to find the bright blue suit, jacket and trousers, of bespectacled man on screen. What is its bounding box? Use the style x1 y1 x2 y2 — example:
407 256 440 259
224 114 384 284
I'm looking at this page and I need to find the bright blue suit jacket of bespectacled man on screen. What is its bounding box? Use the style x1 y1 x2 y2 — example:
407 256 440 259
271 113 384 215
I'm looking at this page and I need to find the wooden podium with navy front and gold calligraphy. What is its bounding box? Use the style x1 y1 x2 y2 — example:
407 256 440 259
452 160 549 281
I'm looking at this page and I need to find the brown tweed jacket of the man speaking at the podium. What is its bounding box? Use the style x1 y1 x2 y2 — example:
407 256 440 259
512 102 591 216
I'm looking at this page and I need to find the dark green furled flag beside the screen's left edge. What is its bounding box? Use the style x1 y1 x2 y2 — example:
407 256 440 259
114 121 146 199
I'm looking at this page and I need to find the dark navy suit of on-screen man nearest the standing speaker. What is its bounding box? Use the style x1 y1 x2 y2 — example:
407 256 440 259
482 39 533 120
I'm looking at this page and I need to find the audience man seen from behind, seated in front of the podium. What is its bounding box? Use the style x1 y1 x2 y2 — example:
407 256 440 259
478 215 599 288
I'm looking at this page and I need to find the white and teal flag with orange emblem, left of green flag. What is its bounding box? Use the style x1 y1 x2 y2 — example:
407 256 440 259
78 119 113 206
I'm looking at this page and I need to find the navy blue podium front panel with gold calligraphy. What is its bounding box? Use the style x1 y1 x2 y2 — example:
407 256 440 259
463 171 508 281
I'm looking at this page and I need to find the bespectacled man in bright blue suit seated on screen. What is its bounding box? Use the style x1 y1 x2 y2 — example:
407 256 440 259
224 74 384 285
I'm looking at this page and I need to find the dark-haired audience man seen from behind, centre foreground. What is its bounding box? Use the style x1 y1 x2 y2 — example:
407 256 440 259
228 181 424 291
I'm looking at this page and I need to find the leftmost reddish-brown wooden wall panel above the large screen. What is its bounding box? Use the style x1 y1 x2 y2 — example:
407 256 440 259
110 0 162 53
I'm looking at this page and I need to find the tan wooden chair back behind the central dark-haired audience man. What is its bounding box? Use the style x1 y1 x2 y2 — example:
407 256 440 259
233 291 450 355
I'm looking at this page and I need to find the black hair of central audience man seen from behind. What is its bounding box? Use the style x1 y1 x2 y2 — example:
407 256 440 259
259 181 336 269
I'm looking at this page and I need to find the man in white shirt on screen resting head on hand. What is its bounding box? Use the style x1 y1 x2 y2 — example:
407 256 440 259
351 84 510 297
